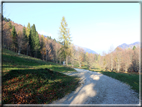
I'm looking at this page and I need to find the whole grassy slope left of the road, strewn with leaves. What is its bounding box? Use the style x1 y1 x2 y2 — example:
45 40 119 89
2 49 79 104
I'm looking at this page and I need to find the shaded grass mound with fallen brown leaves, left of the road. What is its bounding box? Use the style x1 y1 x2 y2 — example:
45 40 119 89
2 69 78 104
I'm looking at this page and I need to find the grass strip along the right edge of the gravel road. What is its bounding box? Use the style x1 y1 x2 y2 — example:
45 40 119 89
79 65 139 93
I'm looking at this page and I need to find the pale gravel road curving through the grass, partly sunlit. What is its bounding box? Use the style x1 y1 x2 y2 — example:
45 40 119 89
52 68 139 104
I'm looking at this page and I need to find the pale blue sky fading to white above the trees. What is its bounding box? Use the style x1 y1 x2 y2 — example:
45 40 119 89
3 3 140 55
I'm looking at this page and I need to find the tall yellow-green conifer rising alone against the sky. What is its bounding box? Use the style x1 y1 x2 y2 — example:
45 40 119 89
59 16 71 65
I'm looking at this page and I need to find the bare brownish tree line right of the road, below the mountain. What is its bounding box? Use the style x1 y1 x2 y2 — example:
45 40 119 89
99 46 140 73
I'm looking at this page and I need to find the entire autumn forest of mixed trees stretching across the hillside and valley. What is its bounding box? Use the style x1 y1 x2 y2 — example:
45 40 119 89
2 17 141 73
